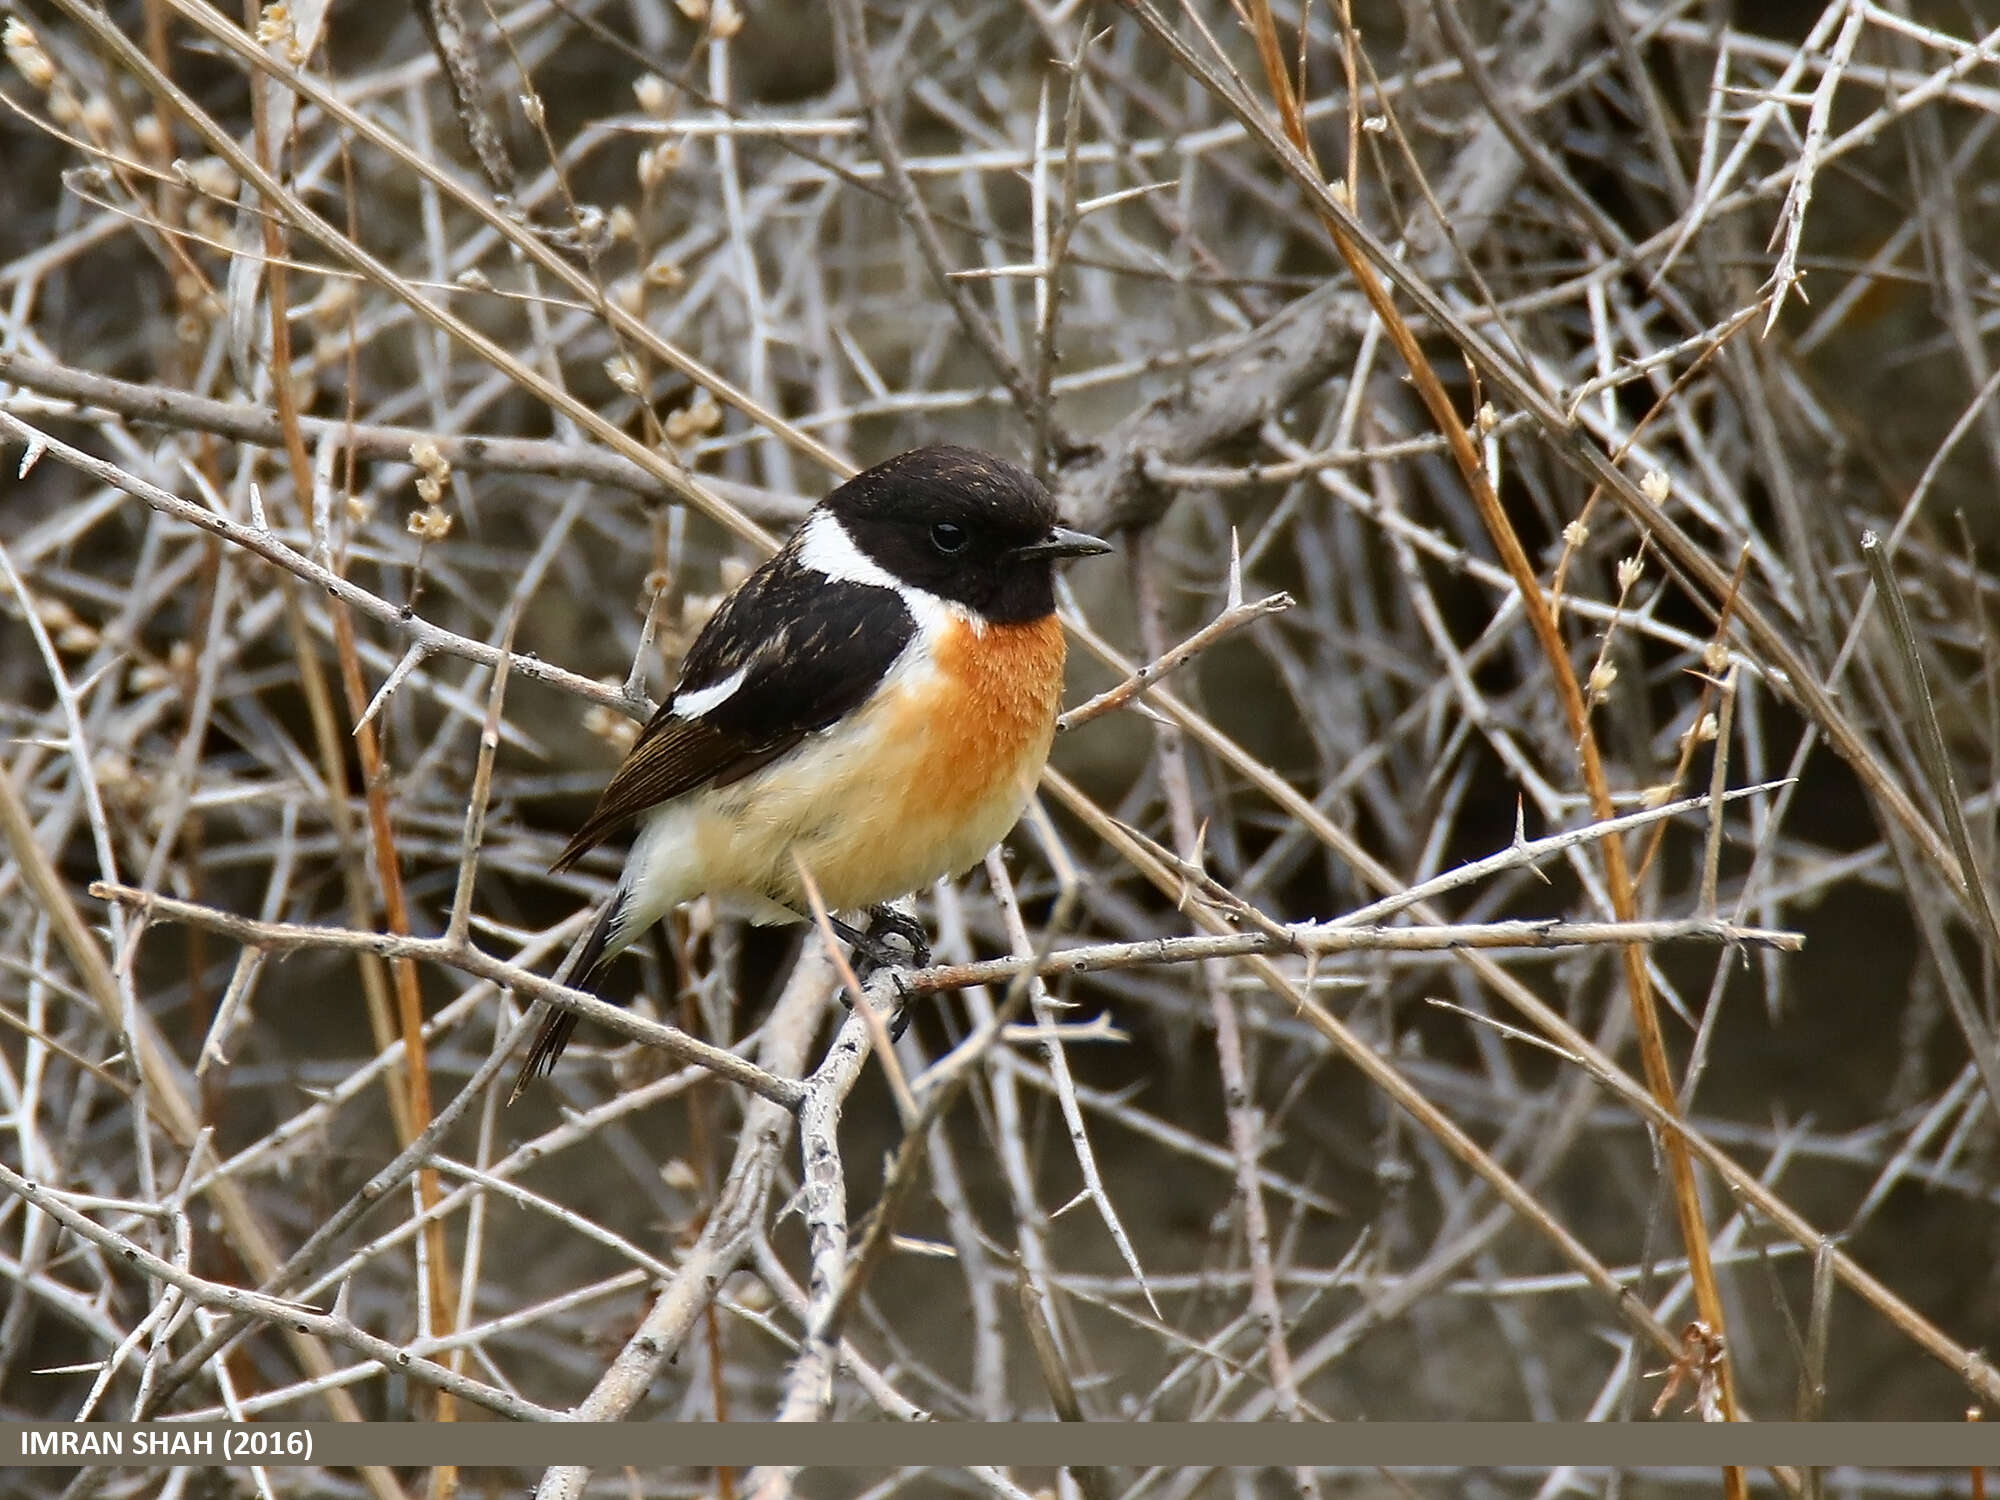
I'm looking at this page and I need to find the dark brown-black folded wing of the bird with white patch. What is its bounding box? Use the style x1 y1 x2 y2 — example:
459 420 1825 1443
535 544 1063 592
550 548 916 870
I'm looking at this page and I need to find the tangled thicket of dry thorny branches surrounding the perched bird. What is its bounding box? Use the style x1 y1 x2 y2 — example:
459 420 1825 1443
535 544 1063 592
0 0 2000 1500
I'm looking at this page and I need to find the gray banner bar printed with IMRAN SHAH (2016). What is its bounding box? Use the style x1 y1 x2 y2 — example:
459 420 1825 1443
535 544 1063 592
0 1422 2000 1468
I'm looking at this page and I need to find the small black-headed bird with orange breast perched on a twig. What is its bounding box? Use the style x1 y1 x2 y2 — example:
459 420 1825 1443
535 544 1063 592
514 444 1112 1098
